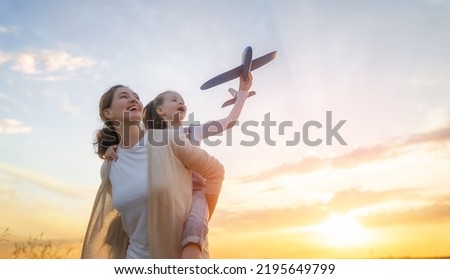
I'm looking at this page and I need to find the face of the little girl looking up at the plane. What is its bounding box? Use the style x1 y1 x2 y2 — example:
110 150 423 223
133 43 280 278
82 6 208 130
158 92 187 122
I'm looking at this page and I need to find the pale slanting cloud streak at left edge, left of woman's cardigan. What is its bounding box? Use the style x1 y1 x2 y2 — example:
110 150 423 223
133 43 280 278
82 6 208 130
0 162 88 198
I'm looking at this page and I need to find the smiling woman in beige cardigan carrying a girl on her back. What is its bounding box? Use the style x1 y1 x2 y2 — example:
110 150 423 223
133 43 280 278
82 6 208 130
81 85 224 258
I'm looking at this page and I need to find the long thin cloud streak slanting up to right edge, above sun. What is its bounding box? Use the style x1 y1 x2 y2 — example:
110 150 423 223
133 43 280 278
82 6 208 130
238 126 450 183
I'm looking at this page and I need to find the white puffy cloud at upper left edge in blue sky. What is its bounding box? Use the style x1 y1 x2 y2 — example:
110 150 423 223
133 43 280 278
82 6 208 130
0 50 95 75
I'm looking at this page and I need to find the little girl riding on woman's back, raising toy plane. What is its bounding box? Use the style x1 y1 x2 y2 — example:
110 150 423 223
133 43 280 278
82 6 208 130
105 74 253 258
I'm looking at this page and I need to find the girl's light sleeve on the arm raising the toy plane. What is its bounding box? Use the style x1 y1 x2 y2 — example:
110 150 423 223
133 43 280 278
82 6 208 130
190 91 249 142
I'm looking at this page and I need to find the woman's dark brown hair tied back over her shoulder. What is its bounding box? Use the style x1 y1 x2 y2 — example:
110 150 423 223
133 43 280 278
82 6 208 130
94 84 126 159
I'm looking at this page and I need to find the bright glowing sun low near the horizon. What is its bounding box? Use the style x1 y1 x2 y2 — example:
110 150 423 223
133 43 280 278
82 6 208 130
313 213 370 247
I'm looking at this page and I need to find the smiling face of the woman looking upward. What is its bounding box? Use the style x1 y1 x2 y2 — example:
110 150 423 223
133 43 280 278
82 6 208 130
103 87 143 122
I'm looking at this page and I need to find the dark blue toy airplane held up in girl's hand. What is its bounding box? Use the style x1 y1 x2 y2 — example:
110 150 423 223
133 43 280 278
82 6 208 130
200 47 277 108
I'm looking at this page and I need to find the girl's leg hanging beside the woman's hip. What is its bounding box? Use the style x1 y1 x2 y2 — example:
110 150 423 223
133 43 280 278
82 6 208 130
181 189 209 259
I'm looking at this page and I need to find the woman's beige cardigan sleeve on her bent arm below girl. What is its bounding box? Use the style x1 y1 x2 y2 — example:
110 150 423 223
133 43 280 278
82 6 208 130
172 133 225 195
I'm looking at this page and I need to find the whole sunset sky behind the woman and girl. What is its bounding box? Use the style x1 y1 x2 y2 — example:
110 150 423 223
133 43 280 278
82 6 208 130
0 0 450 258
